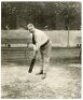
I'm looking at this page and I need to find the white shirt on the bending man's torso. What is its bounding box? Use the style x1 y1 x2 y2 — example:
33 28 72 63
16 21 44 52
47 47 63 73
30 29 49 48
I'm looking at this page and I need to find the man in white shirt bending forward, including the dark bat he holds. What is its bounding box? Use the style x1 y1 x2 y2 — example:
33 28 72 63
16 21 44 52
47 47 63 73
27 24 51 79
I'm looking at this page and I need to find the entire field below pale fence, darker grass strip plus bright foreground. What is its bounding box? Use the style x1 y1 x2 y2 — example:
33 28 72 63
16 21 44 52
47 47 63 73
1 48 81 99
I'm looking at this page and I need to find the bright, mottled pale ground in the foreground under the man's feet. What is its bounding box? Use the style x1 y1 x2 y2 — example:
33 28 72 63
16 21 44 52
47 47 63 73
1 63 81 99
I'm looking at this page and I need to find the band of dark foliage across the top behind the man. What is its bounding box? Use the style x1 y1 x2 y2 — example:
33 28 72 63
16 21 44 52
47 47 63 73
1 2 81 29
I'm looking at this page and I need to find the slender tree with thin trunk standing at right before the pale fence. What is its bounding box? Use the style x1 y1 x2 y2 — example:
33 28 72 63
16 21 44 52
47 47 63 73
61 2 79 47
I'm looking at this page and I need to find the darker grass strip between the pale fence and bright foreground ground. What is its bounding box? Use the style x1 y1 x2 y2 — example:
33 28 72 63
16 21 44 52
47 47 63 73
1 47 80 64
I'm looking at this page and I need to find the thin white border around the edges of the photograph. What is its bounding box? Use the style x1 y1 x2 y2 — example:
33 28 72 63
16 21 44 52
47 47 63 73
0 0 83 100
